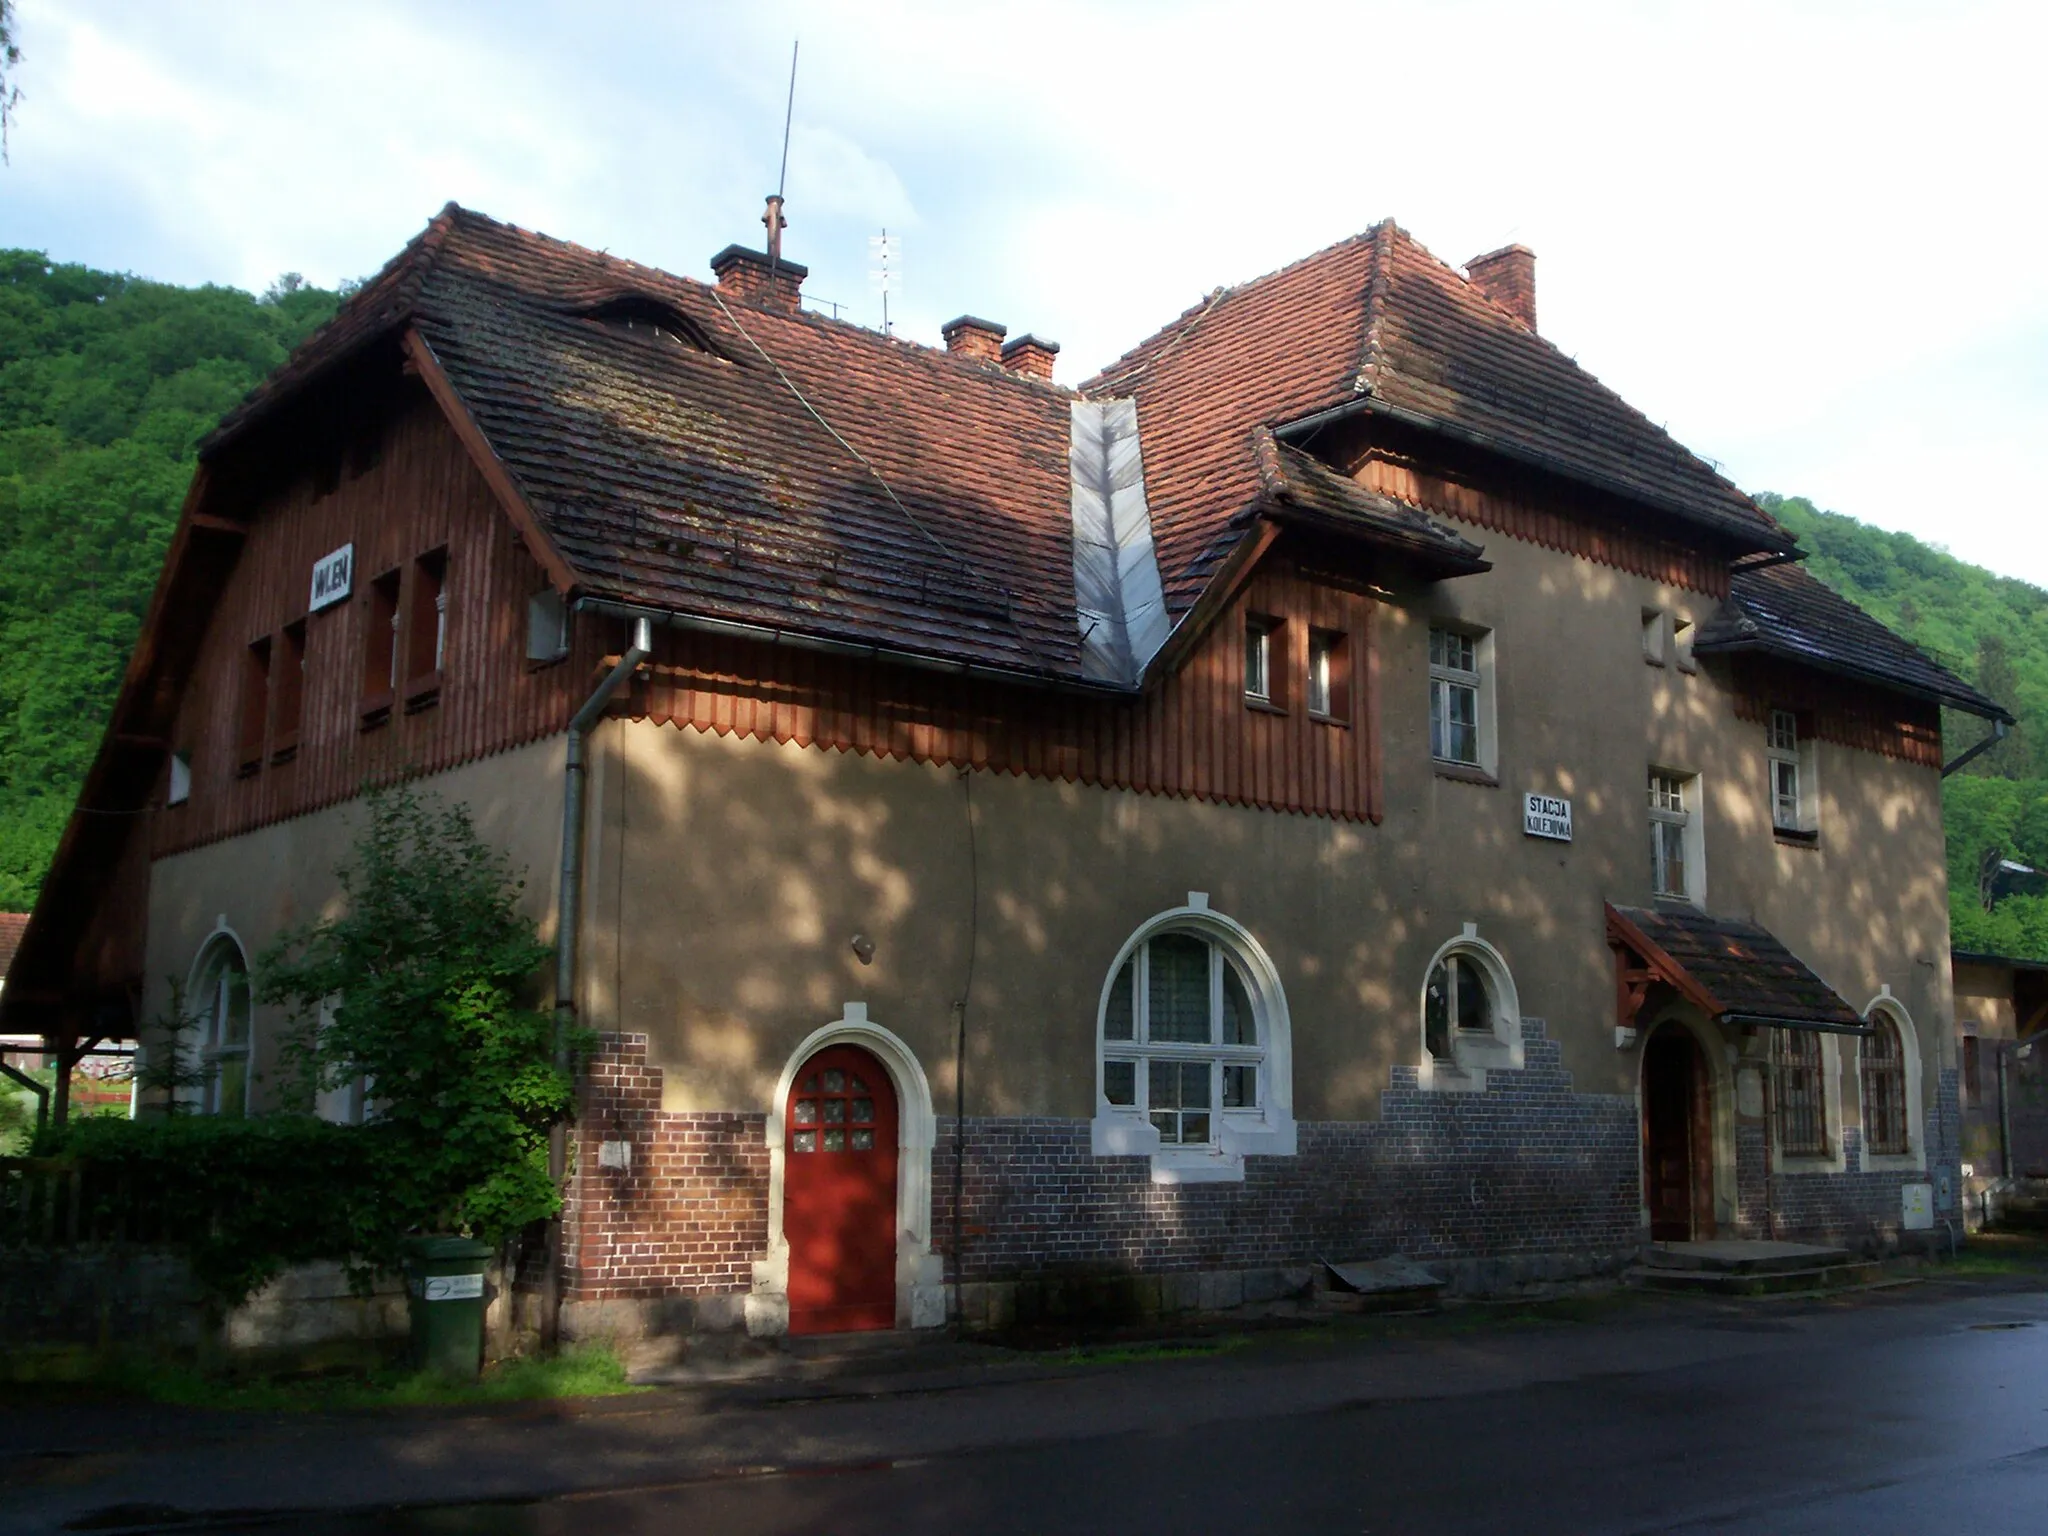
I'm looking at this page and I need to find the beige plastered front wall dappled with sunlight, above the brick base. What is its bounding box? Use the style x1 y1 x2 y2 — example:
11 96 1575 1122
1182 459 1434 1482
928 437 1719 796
584 537 1952 1120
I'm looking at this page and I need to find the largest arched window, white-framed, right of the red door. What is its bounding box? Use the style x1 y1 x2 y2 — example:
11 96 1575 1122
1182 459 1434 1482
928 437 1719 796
1094 893 1294 1182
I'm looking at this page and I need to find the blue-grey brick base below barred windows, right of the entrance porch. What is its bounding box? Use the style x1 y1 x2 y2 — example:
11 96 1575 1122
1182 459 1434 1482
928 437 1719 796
1735 1067 1962 1249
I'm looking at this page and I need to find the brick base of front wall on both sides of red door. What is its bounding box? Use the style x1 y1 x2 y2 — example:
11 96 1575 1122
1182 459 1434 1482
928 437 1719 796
565 1020 1640 1329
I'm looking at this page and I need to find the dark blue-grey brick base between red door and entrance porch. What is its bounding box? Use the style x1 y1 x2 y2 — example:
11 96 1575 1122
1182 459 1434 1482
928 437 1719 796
932 1020 1640 1280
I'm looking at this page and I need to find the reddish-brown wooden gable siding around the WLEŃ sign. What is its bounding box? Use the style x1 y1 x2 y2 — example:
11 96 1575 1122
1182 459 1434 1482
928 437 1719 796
154 391 604 856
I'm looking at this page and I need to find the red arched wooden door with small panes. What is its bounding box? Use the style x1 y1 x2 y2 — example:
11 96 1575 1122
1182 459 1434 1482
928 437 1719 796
782 1044 897 1333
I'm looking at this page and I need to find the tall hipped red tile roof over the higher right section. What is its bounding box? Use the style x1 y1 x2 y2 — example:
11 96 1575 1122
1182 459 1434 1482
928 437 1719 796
1083 221 1792 606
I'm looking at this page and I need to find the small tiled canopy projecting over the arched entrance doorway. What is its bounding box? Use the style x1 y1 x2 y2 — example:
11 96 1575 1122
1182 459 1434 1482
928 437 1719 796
1608 903 1870 1034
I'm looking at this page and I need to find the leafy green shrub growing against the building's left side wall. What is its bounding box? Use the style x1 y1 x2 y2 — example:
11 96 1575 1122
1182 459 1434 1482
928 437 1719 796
256 786 571 1260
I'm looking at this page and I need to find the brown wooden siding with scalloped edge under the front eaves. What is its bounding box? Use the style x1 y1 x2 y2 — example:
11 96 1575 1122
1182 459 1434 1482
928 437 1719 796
631 563 1380 821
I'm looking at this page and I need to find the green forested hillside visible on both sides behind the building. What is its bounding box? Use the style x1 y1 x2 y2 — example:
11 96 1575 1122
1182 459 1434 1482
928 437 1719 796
0 250 2048 958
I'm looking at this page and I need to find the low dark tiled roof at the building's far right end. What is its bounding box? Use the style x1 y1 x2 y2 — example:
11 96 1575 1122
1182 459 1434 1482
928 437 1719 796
1694 565 2013 721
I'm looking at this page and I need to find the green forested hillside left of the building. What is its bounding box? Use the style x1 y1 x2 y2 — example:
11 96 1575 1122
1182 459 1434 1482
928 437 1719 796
0 250 336 909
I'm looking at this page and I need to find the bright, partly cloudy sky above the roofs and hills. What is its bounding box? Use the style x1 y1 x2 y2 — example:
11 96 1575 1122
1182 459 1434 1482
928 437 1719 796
12 0 2048 586
